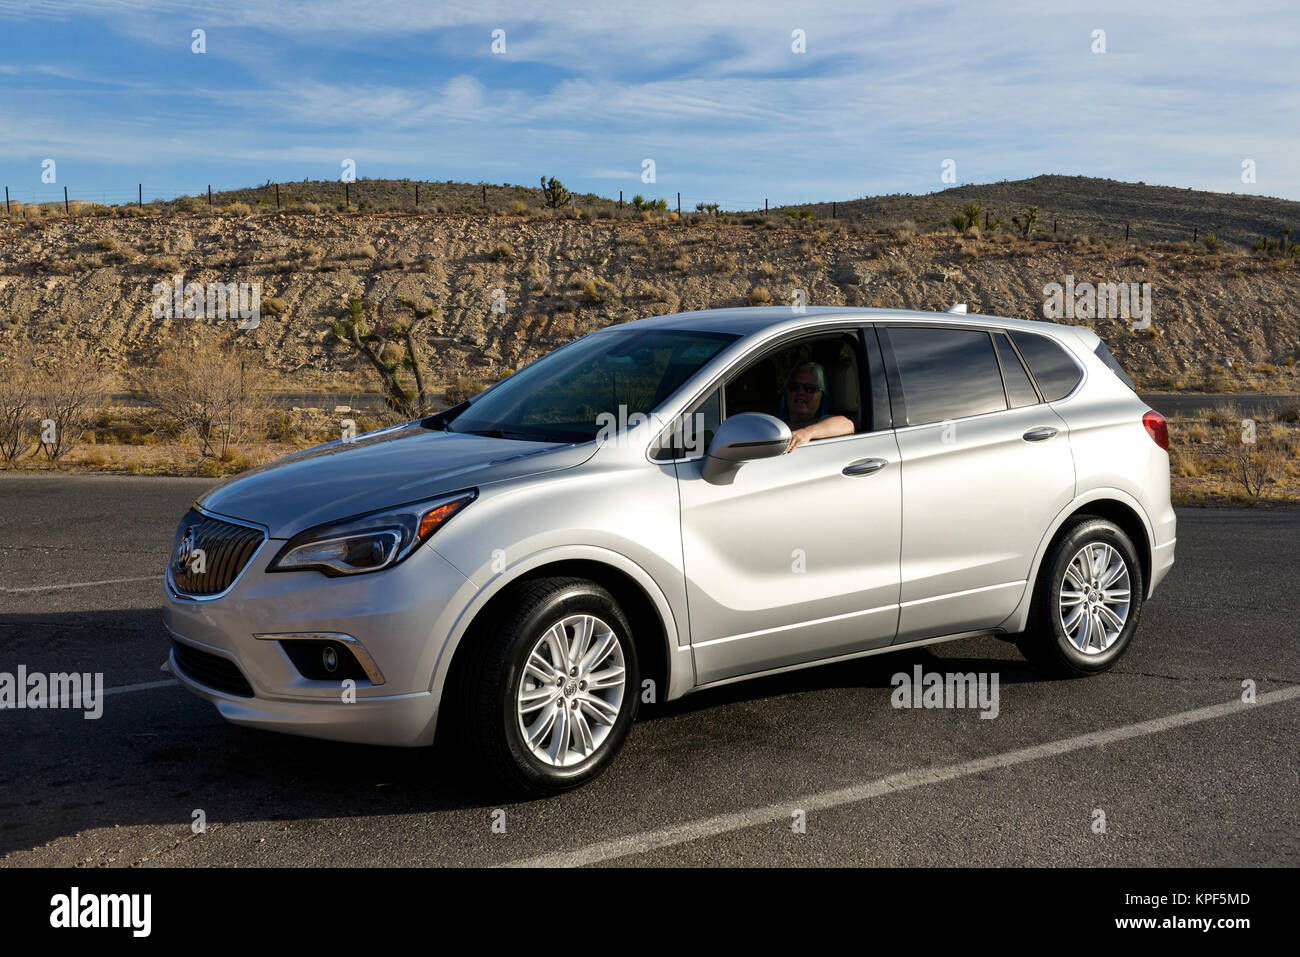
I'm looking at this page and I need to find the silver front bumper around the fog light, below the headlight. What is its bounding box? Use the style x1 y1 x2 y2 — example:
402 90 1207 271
163 542 476 746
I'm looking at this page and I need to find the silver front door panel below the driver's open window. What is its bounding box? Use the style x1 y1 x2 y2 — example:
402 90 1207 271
676 432 902 684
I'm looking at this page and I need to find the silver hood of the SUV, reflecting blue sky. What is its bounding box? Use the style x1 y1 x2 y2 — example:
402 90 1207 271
196 421 595 538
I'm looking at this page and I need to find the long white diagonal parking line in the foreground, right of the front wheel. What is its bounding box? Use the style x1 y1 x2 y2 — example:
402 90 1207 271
506 685 1300 867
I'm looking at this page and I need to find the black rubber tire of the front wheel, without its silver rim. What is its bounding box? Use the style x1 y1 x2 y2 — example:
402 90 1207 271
447 577 640 797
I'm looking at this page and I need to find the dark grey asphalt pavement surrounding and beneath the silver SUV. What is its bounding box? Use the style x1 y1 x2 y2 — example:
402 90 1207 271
0 476 1300 867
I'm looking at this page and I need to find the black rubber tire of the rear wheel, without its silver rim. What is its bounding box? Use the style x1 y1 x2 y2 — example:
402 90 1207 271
1015 518 1147 677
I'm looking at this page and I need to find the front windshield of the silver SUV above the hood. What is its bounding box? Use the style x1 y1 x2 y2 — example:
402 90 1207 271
447 329 740 442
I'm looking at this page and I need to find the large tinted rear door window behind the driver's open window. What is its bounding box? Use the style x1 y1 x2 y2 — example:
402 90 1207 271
888 328 1006 425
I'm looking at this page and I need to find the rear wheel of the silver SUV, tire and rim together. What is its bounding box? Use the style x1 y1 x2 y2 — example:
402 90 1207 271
1015 518 1144 675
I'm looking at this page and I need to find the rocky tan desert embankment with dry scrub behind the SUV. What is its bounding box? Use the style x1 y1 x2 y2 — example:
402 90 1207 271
0 205 1300 391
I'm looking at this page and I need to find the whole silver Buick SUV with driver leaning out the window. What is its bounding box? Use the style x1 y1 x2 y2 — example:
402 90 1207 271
164 307 1175 793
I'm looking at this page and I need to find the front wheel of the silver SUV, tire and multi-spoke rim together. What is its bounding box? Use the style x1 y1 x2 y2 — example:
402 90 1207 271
454 579 640 796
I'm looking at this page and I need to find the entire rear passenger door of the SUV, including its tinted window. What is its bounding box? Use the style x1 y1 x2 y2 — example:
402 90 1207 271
880 325 1075 642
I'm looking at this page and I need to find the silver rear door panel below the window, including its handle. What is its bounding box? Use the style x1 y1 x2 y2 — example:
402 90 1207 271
897 404 1075 641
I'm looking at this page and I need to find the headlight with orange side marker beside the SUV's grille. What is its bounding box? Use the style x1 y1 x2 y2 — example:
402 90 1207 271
267 489 478 576
